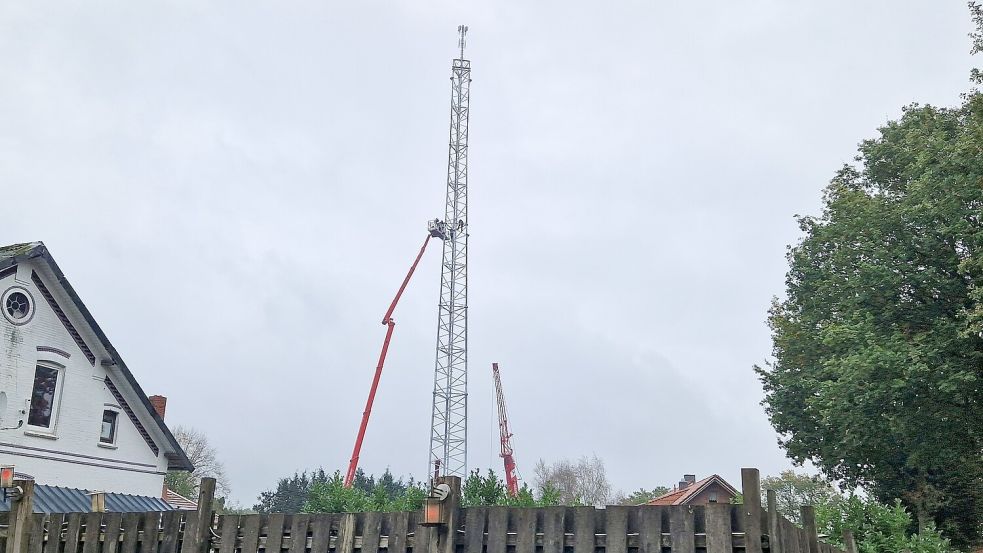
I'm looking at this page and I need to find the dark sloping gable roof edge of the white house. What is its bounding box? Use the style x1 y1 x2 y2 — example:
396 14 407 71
0 242 195 470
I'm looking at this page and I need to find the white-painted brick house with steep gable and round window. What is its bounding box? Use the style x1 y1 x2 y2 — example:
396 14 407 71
0 242 194 497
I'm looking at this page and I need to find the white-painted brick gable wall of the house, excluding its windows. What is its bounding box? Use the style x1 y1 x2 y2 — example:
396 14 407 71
0 262 167 497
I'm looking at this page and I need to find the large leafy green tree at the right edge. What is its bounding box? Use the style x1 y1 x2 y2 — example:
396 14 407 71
755 15 983 546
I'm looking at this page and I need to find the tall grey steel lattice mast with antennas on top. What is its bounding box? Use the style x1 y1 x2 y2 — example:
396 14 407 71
427 25 471 476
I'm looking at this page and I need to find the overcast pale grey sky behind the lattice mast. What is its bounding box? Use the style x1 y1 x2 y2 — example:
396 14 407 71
0 0 972 505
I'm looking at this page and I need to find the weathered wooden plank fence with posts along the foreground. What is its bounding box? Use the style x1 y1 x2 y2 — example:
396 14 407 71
0 469 843 553
